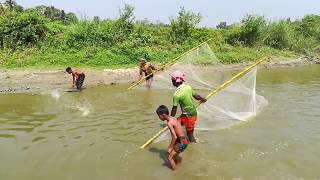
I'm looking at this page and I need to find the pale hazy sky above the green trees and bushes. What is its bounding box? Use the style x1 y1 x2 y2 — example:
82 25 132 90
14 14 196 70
16 0 320 27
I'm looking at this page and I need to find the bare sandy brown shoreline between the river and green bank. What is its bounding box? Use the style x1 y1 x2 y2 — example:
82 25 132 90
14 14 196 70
0 57 320 94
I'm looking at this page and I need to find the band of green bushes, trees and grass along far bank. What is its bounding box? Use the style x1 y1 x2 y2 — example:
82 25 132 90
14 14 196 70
0 0 320 67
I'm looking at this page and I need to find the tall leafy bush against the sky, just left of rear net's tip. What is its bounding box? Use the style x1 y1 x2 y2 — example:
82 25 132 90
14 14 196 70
170 7 202 43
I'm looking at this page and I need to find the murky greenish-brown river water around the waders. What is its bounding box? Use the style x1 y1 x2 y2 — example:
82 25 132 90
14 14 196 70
0 65 320 180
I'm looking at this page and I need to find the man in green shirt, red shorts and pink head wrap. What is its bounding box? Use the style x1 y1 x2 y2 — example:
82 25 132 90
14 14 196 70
171 71 207 143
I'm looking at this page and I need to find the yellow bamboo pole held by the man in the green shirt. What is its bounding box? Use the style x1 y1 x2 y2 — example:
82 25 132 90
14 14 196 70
140 57 267 149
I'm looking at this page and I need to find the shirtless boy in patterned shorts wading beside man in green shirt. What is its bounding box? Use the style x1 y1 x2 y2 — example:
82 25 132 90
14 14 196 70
156 105 188 170
